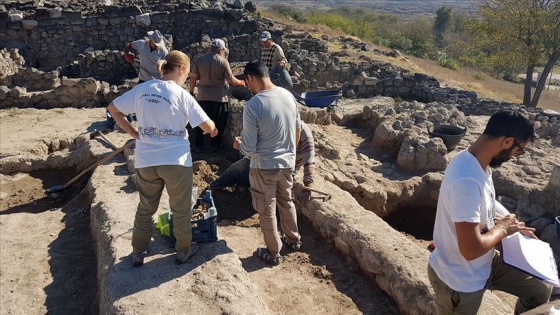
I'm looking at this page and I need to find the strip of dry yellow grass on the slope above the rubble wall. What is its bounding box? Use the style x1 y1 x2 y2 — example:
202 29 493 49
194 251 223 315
263 11 560 112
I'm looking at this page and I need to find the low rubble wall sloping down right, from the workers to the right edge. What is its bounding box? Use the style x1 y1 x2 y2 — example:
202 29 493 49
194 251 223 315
285 36 560 139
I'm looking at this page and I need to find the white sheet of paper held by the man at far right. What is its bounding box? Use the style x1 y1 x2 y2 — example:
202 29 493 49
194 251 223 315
502 233 560 286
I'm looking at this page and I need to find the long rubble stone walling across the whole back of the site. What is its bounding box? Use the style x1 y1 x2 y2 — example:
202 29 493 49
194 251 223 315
0 1 560 142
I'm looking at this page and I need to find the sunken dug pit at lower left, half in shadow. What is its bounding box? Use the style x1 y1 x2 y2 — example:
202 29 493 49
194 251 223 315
0 168 98 315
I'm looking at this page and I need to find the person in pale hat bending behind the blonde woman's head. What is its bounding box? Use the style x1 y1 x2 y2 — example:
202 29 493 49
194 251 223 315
124 30 168 83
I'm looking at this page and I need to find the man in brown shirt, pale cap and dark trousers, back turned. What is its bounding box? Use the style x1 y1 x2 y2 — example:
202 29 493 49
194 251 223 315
189 38 245 153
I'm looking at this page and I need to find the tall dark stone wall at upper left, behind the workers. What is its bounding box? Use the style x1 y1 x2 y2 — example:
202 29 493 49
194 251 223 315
0 2 261 70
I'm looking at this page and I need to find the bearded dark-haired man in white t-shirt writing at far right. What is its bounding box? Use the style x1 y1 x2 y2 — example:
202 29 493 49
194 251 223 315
428 110 552 314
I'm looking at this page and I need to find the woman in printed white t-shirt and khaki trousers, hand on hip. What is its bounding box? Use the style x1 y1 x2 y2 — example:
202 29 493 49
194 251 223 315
107 51 218 267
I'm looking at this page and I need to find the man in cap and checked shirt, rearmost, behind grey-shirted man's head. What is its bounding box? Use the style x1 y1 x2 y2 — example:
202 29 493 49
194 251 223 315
260 31 294 90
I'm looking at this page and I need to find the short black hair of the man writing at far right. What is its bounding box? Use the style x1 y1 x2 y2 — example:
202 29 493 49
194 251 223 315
482 109 536 142
